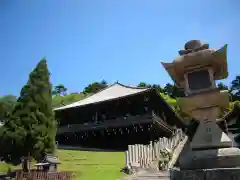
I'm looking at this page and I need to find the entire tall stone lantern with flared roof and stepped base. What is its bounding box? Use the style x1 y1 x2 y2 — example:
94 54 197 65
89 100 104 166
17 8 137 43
162 40 240 179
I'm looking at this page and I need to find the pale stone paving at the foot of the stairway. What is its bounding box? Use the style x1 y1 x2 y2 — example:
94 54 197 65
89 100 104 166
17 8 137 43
123 171 170 180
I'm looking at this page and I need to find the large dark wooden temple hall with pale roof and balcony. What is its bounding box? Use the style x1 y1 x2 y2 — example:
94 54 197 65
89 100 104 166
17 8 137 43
54 82 186 150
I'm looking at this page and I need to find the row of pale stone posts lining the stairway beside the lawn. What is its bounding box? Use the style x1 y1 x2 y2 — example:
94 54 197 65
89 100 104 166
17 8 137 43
125 130 185 169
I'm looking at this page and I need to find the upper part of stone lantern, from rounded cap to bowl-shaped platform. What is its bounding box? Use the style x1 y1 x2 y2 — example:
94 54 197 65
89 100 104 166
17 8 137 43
162 40 229 120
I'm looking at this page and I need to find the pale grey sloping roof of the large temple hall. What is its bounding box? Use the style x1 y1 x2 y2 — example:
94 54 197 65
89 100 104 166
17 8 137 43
54 82 151 111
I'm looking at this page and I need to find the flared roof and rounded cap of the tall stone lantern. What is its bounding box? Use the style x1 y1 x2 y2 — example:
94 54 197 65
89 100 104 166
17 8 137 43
162 40 228 86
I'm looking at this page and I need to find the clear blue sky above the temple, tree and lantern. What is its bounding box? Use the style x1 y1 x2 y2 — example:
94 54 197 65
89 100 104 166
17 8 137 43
0 0 240 95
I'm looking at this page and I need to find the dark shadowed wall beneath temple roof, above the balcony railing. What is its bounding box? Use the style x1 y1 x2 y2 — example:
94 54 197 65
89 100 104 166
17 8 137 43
55 93 151 126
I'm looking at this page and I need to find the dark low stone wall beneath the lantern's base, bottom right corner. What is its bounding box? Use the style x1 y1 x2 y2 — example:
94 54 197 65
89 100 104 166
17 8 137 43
170 168 240 180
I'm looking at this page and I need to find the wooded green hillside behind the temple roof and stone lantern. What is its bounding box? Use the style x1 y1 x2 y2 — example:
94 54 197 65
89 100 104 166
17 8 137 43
0 76 240 115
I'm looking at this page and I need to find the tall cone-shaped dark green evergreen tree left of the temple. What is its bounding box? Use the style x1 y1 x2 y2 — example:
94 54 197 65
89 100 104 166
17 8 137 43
0 58 56 164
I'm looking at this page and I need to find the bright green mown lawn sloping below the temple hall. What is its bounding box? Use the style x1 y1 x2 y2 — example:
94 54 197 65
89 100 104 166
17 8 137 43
0 150 125 180
